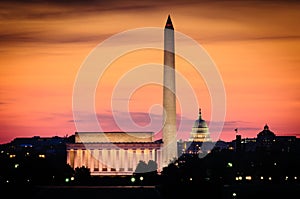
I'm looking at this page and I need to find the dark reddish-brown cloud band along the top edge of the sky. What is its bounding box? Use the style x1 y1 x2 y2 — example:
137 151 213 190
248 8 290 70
0 0 299 20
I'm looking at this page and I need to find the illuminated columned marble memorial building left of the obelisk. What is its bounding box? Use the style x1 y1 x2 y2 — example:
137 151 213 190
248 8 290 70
67 132 162 175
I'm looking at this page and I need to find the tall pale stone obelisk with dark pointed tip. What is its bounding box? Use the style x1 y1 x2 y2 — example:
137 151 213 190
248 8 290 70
162 15 177 167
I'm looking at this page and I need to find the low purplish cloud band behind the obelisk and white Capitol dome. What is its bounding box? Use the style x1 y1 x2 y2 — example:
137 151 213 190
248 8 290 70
69 111 262 137
